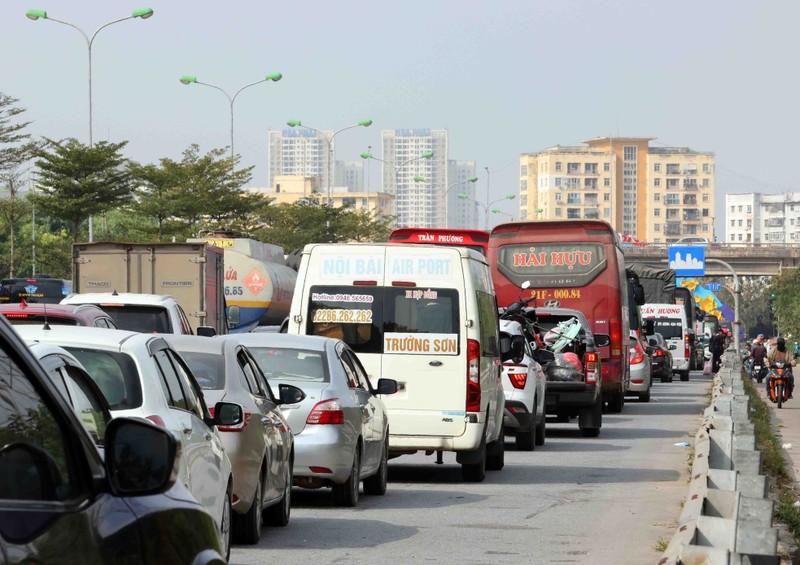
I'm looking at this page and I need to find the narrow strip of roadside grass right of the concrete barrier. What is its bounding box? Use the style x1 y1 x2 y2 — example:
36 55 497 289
743 377 800 545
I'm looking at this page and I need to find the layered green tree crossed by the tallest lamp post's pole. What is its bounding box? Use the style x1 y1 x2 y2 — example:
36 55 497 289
35 138 131 241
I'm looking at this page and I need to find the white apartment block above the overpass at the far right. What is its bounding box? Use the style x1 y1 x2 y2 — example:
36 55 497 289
725 192 800 245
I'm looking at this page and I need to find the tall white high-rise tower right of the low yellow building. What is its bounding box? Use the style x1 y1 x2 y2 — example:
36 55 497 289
382 128 448 228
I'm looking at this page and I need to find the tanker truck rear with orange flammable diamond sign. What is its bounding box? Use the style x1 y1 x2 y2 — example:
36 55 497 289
189 232 297 333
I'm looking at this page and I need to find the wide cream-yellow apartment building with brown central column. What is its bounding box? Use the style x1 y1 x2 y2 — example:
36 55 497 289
520 137 714 243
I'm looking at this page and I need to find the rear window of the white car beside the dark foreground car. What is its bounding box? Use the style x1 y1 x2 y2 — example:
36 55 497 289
66 347 142 410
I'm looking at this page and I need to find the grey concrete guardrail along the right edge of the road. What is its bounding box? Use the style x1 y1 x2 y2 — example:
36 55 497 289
658 351 780 565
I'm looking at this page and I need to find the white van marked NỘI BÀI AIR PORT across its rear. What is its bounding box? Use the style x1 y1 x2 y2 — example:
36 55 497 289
288 244 504 481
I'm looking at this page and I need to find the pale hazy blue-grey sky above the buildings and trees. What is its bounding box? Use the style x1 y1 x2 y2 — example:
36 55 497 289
0 0 800 234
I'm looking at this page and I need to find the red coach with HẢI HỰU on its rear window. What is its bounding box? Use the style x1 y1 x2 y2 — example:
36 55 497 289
488 220 635 412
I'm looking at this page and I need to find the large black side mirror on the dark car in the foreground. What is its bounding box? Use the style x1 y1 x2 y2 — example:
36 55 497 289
105 418 180 496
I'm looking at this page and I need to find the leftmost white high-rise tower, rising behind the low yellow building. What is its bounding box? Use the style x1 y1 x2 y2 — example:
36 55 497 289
267 127 335 192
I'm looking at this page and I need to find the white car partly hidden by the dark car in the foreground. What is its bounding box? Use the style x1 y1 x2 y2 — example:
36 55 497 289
16 326 238 556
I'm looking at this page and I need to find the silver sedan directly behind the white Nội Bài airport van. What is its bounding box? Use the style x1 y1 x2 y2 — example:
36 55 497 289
230 333 397 506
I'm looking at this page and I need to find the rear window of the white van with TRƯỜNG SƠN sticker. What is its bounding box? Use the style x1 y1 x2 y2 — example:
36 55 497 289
306 285 460 355
